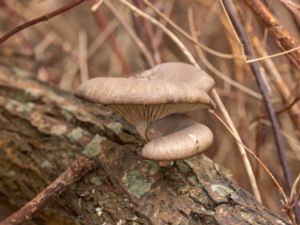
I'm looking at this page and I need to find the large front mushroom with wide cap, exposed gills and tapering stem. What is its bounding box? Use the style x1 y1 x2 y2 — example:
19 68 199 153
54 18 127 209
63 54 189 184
76 78 214 137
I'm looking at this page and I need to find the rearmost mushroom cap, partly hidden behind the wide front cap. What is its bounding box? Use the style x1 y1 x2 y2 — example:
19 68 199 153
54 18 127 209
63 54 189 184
136 62 215 92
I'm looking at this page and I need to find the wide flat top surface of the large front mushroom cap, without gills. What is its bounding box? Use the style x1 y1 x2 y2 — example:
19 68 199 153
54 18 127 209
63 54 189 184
76 77 213 107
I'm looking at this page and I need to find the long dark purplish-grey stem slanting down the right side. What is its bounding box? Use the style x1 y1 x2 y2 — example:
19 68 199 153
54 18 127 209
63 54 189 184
223 0 298 222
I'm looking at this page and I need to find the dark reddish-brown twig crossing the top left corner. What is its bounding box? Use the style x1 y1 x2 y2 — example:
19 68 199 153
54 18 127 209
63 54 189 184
0 0 85 44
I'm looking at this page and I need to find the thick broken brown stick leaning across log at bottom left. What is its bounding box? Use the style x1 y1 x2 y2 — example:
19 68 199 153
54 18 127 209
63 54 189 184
0 156 95 225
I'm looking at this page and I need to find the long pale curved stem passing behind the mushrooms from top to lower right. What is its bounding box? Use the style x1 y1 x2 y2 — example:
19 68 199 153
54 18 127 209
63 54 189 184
119 0 261 201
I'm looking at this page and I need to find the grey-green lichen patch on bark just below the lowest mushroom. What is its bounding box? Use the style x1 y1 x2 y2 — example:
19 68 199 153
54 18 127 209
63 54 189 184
122 170 153 198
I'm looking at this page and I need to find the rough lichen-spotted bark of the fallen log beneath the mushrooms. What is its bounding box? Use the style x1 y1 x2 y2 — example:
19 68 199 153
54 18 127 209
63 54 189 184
0 67 288 225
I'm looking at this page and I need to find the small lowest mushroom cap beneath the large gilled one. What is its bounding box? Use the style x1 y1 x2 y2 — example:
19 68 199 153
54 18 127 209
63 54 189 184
141 114 213 161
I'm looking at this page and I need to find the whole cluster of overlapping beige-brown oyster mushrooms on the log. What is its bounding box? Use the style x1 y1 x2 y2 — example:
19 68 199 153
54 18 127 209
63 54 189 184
76 62 214 165
